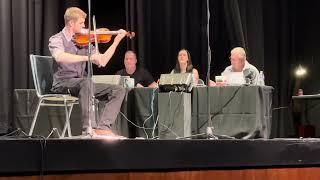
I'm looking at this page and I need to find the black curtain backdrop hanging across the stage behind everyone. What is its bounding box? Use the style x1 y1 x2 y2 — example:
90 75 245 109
0 0 320 137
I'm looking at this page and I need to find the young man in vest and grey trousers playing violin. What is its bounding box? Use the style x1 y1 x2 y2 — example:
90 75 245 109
49 7 127 136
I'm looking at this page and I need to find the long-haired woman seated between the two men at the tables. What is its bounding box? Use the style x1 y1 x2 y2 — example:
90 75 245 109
171 49 199 85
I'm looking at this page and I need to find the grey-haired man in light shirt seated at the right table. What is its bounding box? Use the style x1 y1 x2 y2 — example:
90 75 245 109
210 47 259 86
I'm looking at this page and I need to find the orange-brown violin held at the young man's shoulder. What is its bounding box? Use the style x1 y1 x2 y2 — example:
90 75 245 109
74 28 135 47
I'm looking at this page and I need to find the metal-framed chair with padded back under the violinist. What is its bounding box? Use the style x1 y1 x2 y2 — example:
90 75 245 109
29 54 78 138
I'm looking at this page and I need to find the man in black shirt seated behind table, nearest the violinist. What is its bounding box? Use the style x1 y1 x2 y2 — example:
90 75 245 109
116 51 158 88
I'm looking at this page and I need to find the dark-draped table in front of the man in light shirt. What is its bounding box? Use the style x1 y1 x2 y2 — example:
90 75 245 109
192 86 273 139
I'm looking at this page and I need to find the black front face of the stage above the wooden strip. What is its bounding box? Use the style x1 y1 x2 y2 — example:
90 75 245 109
0 137 320 174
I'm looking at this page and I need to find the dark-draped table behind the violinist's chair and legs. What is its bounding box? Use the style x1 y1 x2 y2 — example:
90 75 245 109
13 88 158 138
